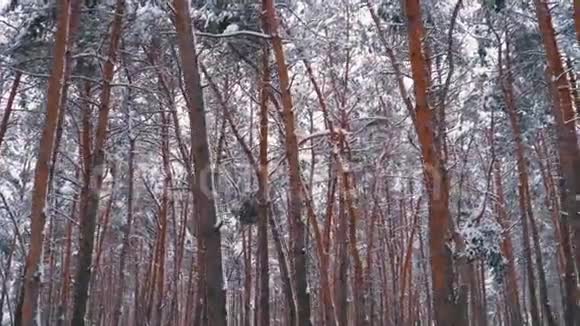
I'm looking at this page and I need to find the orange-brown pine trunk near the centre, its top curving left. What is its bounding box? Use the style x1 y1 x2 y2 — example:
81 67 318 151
262 0 311 326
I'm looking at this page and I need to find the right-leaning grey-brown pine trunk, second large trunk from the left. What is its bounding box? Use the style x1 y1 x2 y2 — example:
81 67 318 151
72 0 125 326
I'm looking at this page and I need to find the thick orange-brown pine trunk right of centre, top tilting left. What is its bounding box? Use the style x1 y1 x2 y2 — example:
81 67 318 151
405 0 459 326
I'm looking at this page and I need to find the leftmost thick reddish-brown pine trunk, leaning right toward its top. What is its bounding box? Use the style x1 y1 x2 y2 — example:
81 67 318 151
17 0 71 326
